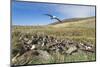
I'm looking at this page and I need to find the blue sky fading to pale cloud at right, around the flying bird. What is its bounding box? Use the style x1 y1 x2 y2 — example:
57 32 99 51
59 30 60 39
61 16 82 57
12 1 95 25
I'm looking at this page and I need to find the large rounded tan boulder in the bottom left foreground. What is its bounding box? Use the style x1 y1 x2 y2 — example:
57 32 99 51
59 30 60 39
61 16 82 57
12 50 51 65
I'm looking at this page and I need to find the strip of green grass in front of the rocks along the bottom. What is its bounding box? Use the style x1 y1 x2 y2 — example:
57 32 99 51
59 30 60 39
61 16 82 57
30 53 95 64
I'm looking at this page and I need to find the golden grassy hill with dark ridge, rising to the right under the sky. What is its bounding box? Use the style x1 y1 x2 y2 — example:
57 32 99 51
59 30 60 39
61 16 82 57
49 17 96 28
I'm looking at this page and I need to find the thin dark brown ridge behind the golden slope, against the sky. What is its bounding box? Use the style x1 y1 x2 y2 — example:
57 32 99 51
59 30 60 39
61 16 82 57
49 16 95 25
